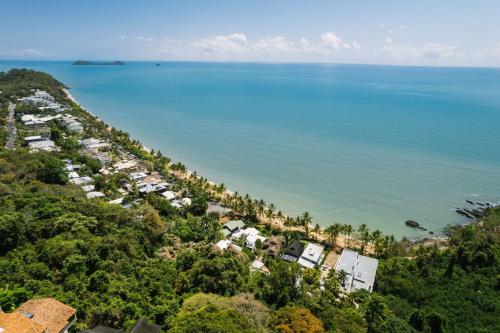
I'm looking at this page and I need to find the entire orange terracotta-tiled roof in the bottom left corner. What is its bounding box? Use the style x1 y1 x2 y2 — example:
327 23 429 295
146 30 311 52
0 298 76 333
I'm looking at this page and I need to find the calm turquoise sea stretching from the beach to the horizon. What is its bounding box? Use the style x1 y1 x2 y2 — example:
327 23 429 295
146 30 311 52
0 61 500 236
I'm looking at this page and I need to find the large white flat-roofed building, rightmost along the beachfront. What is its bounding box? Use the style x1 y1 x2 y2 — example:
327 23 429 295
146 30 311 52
334 249 378 292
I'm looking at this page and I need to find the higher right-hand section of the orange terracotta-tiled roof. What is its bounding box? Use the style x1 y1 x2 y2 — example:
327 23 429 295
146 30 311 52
15 298 76 333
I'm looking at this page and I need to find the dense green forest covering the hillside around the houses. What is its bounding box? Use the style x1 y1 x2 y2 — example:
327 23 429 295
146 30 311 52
0 70 500 333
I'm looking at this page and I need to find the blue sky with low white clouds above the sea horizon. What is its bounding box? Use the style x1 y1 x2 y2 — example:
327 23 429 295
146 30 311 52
0 0 500 67
